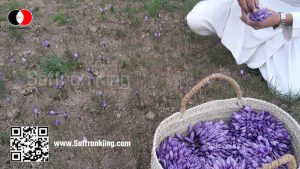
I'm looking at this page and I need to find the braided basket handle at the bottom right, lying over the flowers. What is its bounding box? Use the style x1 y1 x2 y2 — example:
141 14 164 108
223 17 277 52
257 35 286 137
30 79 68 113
260 154 297 169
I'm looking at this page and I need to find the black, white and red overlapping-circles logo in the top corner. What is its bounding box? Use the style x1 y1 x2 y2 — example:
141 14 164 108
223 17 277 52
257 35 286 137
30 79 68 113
8 9 32 26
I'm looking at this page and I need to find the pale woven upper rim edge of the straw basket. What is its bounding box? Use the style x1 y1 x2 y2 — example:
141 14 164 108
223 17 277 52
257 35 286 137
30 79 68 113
151 97 300 169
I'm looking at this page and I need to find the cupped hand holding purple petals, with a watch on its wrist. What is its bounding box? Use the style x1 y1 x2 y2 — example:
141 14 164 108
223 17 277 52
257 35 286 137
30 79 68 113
241 10 280 30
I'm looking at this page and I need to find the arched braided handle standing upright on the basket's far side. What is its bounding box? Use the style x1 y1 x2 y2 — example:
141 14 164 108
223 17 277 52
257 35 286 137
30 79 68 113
180 73 242 113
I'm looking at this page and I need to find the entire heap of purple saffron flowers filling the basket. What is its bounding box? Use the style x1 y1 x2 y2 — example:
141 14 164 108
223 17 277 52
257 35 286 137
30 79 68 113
156 106 293 169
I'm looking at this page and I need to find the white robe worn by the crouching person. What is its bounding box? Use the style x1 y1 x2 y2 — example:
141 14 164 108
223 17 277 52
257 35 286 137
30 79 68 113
186 0 300 96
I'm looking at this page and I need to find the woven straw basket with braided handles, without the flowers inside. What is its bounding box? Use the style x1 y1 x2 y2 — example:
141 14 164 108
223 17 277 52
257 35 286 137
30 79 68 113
151 73 300 169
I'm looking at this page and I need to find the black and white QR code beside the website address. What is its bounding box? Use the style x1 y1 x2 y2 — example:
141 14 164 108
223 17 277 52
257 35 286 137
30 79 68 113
10 127 49 162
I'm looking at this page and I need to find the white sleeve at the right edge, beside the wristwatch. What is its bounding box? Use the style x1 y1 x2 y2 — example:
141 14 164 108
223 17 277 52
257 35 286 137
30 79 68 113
283 12 300 40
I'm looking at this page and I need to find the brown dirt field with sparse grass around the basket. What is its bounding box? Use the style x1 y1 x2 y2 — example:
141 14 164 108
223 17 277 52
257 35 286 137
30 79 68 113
0 0 300 169
